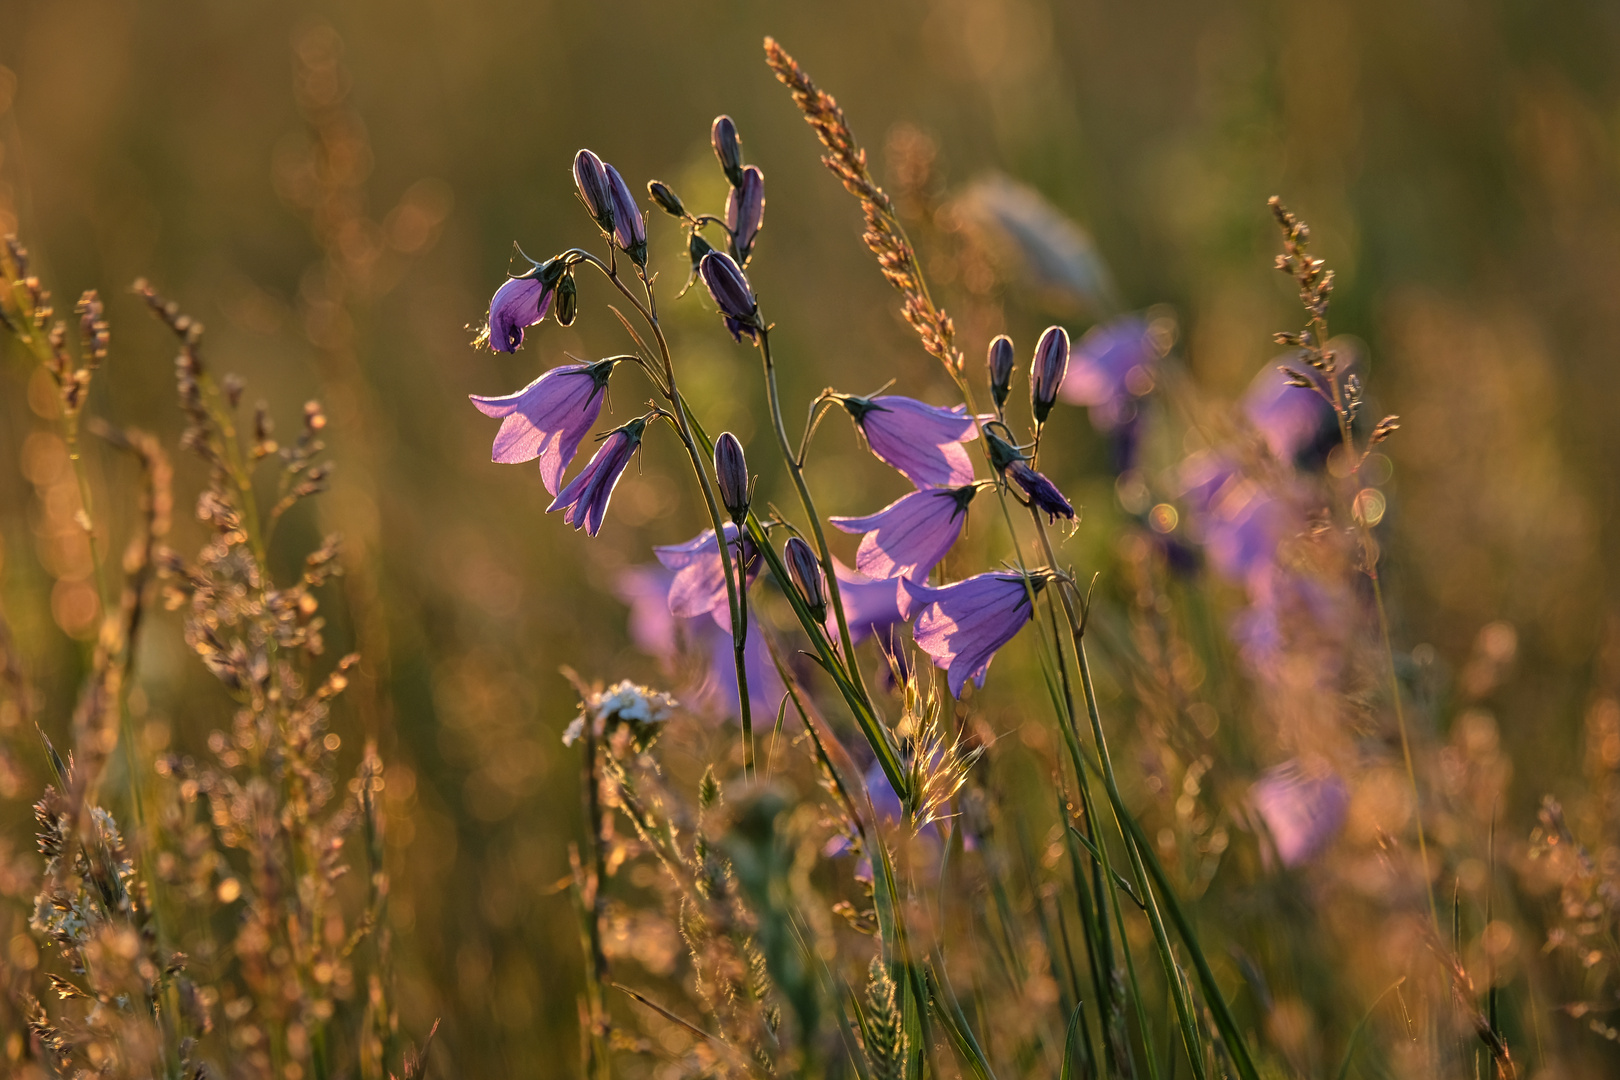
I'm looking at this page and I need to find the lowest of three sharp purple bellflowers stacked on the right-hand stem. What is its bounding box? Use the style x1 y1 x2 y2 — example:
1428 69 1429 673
901 570 1047 696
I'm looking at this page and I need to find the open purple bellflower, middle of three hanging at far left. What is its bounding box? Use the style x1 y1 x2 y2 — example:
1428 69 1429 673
470 359 617 495
